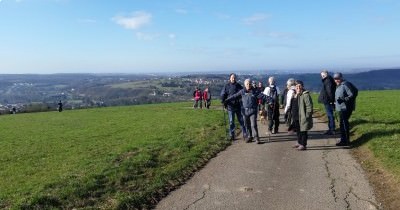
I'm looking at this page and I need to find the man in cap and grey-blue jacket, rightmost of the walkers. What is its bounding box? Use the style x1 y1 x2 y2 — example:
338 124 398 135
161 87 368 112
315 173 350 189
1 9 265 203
333 73 353 146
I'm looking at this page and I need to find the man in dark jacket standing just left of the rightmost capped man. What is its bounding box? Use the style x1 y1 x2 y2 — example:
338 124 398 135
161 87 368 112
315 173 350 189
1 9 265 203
318 70 336 135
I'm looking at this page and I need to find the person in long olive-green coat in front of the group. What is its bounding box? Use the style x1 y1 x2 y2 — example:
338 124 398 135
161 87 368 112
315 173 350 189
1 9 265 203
292 80 313 150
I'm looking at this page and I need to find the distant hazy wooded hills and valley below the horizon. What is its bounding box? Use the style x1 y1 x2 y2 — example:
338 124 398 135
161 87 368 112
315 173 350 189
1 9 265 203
0 69 400 111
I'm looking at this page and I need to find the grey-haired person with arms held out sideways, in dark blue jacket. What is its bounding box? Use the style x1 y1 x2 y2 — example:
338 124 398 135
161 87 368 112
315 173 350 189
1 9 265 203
225 79 266 144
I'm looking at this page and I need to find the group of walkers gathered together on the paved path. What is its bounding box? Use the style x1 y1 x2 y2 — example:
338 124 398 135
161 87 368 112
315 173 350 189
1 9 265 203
217 70 358 150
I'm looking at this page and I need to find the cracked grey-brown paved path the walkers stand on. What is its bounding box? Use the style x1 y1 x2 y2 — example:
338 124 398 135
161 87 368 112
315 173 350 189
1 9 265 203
156 112 379 210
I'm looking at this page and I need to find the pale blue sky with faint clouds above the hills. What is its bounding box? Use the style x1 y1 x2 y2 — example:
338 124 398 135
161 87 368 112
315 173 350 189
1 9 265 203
0 0 400 74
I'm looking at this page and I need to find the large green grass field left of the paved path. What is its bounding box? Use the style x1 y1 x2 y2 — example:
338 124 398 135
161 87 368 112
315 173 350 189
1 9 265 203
0 103 229 209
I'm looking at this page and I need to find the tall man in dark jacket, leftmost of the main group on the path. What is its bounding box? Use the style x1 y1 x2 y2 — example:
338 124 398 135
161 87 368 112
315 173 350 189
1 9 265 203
221 73 247 140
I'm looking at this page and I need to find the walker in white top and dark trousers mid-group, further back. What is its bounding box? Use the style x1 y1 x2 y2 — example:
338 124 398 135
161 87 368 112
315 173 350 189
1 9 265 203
264 77 281 135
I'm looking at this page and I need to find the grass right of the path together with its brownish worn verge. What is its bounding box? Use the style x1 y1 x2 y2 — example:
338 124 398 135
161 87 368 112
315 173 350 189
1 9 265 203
314 90 400 209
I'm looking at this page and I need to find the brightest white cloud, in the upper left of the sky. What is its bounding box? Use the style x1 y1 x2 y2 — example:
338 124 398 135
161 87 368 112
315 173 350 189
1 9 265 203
112 11 152 30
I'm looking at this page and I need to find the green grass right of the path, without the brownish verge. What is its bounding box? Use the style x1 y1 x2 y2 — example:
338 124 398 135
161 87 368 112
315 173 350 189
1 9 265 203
313 90 400 181
